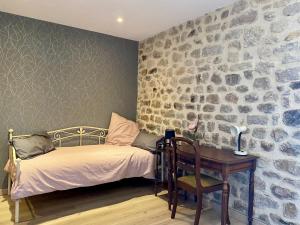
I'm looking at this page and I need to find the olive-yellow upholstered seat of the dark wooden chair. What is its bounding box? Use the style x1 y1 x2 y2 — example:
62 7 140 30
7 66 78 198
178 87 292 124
178 174 223 188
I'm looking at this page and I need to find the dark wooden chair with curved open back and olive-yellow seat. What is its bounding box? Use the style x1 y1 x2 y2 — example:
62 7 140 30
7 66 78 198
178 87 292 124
169 137 230 225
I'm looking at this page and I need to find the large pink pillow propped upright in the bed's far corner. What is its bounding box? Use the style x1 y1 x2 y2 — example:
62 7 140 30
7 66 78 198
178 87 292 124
105 113 140 145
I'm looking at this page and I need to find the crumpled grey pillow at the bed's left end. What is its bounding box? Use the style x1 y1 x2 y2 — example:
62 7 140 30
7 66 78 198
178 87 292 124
12 133 55 159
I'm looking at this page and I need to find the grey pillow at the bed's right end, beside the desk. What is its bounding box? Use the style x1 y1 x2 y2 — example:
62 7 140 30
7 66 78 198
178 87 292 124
132 131 163 151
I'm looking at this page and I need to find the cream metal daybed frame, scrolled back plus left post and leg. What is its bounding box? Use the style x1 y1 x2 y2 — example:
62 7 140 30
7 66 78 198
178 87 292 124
8 126 108 223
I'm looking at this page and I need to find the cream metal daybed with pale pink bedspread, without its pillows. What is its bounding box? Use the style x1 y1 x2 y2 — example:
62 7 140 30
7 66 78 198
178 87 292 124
6 126 155 223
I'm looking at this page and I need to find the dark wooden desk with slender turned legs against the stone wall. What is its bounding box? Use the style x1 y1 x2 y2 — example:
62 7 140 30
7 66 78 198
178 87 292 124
167 146 258 225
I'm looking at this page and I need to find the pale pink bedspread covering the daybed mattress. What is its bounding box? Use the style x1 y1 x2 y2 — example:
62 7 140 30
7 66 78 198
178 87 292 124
11 145 155 199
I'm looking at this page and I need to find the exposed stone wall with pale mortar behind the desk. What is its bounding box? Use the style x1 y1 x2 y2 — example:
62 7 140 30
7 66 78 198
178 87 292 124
137 0 300 224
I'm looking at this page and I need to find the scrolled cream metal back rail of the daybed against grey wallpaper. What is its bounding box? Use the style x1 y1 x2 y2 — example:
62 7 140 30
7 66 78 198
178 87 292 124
8 126 108 147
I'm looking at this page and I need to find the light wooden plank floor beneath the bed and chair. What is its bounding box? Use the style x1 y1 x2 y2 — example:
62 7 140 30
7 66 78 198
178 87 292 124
0 179 240 225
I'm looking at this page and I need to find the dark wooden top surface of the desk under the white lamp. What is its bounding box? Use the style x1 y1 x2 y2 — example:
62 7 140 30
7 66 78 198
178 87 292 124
180 145 258 164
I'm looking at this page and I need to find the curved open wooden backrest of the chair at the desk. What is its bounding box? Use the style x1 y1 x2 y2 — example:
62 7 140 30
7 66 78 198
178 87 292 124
171 137 203 189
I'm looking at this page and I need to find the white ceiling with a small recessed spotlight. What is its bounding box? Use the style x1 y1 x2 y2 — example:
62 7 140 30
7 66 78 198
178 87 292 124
0 0 234 41
